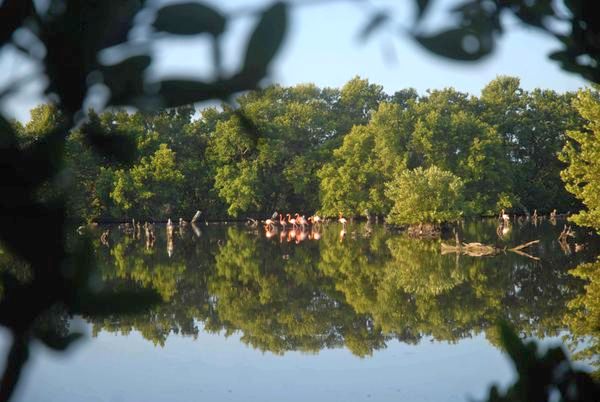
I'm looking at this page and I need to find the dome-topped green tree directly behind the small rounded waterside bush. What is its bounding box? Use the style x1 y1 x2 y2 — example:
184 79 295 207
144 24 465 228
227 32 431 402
409 89 512 214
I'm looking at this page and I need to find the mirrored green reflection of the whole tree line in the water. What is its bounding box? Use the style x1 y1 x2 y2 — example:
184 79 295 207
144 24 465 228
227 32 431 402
65 225 600 357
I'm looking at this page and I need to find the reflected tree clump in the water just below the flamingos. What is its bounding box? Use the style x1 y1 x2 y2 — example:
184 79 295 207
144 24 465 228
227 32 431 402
208 229 383 355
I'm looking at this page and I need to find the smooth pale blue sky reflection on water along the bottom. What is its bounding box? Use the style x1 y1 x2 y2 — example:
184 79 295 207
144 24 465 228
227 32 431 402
2 324 512 402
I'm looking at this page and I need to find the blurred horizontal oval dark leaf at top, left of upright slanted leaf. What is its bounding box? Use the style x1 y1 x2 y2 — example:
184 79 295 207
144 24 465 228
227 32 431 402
153 2 227 36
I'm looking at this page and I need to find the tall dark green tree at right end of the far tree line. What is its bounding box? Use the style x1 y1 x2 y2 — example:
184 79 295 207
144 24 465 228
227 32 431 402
479 76 581 212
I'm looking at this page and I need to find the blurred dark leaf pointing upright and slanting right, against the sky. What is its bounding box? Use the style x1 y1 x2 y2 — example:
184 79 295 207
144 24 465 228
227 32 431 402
243 2 288 80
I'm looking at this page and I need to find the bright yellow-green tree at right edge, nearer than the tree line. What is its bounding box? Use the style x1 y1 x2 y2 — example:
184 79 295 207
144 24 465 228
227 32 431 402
560 90 600 230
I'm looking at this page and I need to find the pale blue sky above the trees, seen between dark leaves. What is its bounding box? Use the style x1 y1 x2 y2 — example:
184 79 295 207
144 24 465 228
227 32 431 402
0 0 586 120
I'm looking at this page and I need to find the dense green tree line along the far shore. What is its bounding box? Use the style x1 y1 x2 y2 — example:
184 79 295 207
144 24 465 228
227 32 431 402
17 77 587 223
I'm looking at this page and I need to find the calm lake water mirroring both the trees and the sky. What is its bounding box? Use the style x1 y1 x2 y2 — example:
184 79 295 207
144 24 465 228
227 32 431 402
2 220 600 402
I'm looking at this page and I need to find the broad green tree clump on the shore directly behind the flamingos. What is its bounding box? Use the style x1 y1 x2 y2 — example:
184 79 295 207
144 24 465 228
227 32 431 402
207 78 382 216
